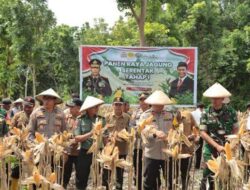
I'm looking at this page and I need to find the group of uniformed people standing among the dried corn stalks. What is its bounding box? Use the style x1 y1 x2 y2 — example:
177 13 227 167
0 80 250 190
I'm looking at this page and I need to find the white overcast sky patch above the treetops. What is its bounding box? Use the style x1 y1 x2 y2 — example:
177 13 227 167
48 0 124 26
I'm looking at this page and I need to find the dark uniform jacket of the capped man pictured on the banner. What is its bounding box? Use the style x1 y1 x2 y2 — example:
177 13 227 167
83 75 112 96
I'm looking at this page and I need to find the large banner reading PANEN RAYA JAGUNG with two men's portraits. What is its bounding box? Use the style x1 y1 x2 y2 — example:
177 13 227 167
79 46 198 106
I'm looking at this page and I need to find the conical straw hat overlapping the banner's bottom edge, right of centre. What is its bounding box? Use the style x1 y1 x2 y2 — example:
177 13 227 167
145 90 173 105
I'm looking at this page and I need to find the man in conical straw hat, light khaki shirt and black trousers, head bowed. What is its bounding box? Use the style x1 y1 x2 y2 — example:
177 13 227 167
140 90 173 190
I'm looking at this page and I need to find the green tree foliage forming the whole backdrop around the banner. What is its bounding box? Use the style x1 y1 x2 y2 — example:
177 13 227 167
0 0 250 109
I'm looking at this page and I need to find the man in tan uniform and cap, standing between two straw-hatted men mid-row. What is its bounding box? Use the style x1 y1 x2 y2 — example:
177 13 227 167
103 97 130 190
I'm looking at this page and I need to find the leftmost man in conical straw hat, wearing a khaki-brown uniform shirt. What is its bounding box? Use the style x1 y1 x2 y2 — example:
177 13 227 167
29 88 66 139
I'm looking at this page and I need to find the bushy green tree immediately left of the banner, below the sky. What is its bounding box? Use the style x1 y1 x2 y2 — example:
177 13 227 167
42 25 79 94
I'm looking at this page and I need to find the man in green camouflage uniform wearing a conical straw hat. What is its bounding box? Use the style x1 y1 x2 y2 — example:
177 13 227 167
200 83 238 190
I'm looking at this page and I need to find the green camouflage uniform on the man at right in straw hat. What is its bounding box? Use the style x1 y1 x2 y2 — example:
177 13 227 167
200 105 237 190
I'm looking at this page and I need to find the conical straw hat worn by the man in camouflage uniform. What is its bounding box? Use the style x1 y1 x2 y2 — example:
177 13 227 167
203 82 231 98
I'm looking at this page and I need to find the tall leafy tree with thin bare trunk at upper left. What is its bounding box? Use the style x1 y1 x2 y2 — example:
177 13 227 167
10 0 55 95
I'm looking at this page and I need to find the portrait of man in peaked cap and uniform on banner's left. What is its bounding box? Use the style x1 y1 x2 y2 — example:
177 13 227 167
83 59 112 97
